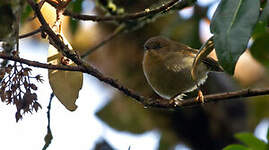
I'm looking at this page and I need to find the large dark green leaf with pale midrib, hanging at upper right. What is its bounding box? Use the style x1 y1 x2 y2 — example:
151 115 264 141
210 0 260 74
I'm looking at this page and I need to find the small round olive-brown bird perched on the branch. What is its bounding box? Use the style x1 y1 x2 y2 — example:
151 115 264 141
142 36 223 103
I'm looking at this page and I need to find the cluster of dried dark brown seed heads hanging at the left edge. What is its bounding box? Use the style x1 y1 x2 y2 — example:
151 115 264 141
0 52 43 121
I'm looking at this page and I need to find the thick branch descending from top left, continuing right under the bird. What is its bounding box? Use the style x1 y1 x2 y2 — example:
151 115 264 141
24 0 269 109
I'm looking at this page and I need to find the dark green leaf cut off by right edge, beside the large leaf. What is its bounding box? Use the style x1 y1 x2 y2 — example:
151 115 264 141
250 32 269 68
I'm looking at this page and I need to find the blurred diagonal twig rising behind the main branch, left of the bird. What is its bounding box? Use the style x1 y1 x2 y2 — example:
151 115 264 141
81 25 126 58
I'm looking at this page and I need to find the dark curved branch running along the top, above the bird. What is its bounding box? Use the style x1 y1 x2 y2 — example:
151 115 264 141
64 0 195 21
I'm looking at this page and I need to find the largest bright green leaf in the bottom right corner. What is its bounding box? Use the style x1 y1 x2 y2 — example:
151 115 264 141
235 133 267 150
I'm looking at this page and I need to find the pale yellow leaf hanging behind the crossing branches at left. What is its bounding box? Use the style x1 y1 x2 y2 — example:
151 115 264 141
47 34 83 111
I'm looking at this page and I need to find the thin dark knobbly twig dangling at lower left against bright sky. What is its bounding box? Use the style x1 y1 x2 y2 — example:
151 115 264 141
42 93 54 150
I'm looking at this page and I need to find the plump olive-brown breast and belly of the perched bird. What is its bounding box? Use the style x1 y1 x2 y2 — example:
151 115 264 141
143 52 206 99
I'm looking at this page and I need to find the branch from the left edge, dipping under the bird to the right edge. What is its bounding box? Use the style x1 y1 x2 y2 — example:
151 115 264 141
0 53 269 109
